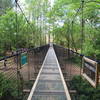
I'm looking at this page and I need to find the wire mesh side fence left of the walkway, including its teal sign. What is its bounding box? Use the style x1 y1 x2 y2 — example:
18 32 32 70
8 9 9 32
0 45 49 100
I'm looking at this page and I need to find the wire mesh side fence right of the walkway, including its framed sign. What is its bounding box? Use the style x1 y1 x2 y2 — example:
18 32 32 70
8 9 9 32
53 44 100 100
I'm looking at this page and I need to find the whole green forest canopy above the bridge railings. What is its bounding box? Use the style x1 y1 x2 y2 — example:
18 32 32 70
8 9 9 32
0 0 100 59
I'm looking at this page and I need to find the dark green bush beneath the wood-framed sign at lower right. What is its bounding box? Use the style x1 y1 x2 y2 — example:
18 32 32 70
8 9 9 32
71 76 100 100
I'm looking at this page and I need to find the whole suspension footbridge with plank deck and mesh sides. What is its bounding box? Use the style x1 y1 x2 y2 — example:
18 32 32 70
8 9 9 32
0 44 100 100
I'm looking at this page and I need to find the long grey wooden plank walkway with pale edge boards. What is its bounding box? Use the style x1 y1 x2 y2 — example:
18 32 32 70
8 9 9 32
27 46 71 100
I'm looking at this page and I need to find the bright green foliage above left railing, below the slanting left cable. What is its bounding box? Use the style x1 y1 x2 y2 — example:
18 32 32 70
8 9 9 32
0 9 44 55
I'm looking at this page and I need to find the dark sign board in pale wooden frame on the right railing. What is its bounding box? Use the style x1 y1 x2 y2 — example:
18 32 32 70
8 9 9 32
82 57 99 87
